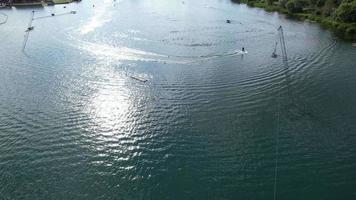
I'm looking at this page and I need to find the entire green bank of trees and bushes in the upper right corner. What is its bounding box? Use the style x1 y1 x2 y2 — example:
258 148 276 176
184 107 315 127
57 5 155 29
231 0 356 40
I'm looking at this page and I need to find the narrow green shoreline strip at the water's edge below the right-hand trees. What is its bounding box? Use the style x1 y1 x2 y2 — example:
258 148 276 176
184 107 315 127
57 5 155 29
235 0 356 41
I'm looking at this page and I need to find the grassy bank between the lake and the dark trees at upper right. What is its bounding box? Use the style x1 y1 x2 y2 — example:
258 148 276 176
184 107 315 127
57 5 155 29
234 0 356 40
